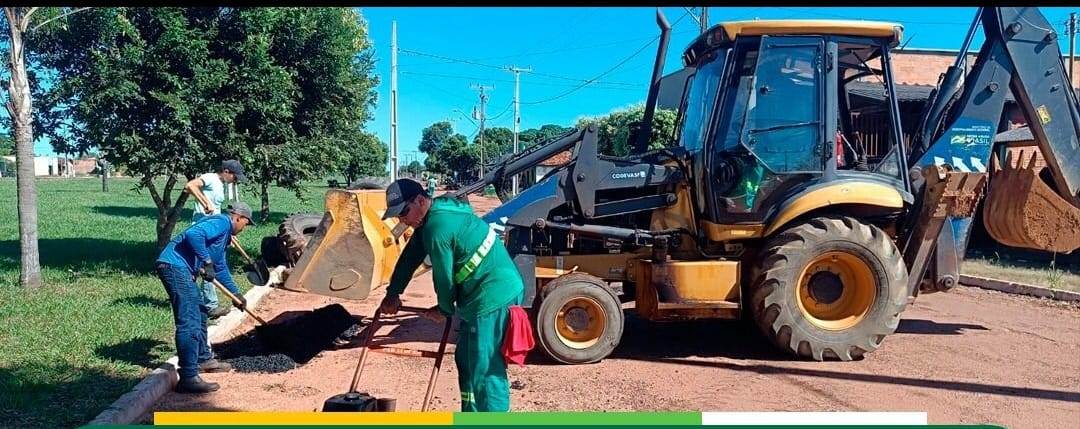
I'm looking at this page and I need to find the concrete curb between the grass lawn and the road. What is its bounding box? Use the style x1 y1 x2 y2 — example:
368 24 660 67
89 286 273 425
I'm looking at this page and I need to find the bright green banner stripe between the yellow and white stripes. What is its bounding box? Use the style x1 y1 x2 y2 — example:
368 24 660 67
454 412 701 426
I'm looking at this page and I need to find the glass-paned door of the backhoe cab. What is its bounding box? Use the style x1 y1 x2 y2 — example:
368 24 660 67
706 36 835 224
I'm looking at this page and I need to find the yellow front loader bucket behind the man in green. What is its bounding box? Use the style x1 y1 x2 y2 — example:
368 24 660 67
281 189 408 299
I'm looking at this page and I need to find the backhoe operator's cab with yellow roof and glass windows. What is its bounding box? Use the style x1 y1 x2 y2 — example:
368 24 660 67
676 21 912 230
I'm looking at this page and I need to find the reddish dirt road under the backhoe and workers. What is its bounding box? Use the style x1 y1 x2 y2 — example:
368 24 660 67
147 196 1080 428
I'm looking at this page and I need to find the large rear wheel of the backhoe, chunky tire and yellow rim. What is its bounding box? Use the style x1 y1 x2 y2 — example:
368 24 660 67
750 217 908 361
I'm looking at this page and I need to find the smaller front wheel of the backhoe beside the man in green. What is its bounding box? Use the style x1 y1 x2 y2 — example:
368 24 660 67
535 272 623 364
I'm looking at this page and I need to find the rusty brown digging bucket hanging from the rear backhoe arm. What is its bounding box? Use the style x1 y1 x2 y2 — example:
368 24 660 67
983 147 1080 253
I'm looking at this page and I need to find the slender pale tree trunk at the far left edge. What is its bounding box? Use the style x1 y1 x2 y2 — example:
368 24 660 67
4 8 41 289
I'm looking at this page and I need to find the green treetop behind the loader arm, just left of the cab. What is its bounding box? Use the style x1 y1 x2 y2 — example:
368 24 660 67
577 104 677 157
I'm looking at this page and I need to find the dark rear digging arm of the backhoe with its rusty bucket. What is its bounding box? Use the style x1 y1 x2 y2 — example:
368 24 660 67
908 8 1080 289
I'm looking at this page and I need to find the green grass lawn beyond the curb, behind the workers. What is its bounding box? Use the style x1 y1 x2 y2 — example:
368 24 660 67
0 178 325 428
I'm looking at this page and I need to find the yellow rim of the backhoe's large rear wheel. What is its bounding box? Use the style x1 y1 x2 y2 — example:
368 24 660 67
795 251 877 331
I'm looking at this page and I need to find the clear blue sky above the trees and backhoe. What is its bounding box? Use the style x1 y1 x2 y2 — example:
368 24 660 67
10 6 1076 164
